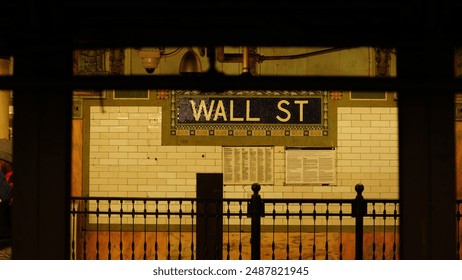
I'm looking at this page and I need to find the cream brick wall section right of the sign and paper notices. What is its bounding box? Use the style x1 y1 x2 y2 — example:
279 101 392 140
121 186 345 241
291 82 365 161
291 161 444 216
335 107 398 199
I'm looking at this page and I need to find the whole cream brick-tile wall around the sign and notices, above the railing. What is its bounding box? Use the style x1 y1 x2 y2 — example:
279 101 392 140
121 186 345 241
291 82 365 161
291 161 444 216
89 106 398 198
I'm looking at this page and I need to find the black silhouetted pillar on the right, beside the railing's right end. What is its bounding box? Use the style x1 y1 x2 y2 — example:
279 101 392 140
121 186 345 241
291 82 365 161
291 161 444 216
397 45 456 259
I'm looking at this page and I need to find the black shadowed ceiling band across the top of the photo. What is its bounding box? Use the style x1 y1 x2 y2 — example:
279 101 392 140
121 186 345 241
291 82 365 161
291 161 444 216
0 0 462 55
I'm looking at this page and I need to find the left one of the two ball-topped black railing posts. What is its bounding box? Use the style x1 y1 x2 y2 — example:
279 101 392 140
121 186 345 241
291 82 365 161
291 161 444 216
247 183 264 260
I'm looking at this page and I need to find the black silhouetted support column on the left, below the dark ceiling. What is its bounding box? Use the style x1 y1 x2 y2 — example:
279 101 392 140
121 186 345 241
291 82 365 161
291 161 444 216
13 48 72 260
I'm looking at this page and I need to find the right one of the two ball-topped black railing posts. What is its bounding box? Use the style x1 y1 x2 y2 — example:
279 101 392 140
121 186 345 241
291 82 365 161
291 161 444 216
352 184 367 260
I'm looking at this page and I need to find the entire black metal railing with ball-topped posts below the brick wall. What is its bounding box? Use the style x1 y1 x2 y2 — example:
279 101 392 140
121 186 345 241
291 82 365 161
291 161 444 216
71 184 416 260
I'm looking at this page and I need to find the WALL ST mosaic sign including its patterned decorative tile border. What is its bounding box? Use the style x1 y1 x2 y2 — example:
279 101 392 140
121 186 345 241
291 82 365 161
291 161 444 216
168 90 335 146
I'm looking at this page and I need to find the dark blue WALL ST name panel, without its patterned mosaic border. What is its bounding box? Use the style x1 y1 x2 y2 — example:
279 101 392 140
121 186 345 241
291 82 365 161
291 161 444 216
177 96 323 125
